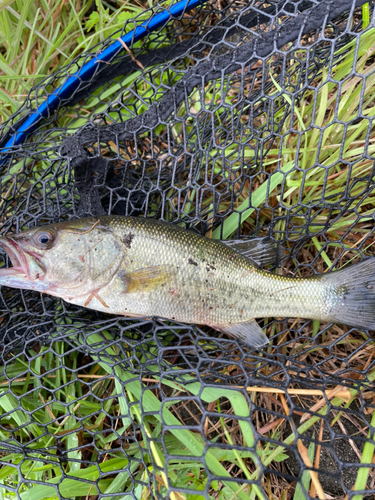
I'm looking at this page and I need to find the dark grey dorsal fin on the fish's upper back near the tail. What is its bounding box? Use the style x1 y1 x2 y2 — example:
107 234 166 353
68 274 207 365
222 236 285 266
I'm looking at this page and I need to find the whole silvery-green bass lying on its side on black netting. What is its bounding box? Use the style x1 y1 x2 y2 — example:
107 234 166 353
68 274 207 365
0 216 375 348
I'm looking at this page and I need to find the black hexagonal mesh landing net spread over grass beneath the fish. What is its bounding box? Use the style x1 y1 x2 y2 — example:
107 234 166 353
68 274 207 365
0 0 375 500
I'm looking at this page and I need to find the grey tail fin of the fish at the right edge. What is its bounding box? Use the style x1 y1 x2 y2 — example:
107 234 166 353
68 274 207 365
324 257 375 330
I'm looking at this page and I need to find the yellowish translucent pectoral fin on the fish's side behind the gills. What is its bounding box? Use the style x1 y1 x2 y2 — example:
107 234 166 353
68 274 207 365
117 266 176 293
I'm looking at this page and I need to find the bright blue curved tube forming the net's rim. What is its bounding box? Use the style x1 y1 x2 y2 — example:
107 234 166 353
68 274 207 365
2 0 205 152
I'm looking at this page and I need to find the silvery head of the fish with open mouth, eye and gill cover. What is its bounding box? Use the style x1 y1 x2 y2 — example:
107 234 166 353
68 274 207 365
0 219 123 298
